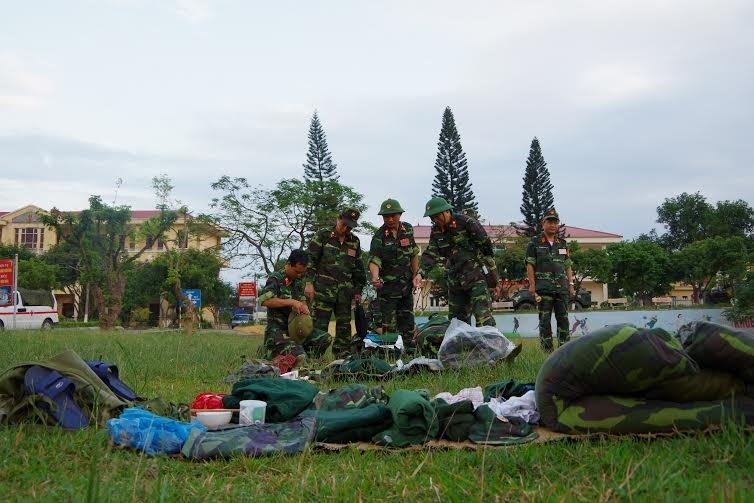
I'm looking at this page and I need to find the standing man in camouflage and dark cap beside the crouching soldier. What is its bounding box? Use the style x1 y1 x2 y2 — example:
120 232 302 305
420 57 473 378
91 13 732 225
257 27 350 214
304 208 366 358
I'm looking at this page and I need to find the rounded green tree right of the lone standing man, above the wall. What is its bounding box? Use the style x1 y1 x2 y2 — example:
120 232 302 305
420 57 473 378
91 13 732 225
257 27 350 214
606 240 670 305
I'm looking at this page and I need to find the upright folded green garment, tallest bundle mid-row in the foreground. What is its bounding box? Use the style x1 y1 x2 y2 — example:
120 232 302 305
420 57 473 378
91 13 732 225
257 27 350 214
372 389 440 447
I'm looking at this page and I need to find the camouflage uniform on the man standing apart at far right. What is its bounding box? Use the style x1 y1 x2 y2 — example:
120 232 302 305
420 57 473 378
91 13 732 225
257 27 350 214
526 232 571 351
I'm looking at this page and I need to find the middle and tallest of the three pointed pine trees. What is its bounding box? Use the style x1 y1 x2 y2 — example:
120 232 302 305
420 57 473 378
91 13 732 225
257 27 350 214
432 107 479 218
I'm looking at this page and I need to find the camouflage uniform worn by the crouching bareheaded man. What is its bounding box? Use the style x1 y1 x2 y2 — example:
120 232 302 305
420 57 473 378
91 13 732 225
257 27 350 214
257 270 330 358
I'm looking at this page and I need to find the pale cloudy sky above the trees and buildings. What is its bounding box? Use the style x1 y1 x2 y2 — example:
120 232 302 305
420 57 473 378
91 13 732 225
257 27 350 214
0 0 754 272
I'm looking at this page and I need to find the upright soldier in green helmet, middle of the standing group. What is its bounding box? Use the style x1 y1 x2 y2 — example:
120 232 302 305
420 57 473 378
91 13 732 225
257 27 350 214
369 199 419 351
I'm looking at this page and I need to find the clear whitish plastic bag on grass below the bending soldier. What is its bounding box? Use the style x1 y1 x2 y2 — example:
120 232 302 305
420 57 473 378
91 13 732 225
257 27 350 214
437 318 516 368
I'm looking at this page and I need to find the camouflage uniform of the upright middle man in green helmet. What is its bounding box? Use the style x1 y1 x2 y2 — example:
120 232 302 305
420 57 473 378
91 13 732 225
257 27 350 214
369 222 419 345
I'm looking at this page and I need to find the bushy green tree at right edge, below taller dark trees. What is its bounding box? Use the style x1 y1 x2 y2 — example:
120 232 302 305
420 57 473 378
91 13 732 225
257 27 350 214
672 237 749 303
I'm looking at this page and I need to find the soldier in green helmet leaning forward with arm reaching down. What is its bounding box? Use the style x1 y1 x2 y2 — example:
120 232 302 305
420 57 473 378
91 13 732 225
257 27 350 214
414 197 497 326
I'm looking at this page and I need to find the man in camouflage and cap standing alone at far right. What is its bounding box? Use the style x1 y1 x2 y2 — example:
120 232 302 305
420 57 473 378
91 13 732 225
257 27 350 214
526 208 574 352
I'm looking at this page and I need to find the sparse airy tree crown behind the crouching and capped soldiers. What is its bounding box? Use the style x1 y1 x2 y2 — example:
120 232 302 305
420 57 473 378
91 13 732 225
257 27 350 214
204 176 372 275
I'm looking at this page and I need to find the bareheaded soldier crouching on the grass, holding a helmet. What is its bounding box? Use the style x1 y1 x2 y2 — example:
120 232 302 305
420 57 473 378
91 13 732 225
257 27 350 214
259 250 330 361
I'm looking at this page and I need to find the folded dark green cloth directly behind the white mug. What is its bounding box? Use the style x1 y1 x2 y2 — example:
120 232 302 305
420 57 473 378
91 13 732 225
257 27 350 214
223 378 317 423
